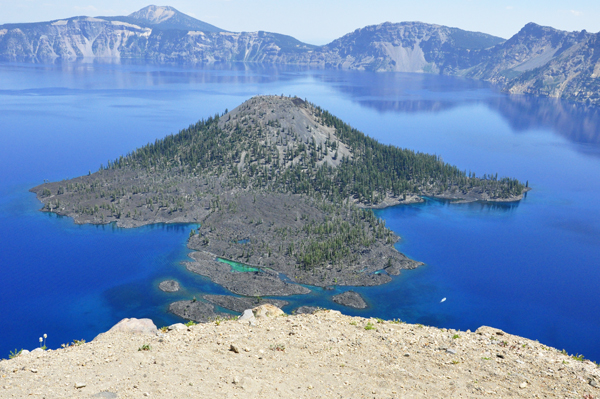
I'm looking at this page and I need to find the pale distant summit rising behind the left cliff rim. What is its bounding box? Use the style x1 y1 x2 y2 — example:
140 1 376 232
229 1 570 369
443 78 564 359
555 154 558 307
128 5 224 32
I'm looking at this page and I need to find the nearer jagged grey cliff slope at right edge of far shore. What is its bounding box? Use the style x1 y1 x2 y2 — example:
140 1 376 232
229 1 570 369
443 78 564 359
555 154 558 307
459 23 600 104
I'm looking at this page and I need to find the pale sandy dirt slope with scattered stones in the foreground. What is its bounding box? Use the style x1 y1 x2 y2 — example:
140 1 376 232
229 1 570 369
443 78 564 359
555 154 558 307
0 305 600 399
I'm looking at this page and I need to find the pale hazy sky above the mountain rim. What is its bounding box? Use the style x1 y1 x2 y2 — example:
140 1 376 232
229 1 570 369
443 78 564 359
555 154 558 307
0 0 600 44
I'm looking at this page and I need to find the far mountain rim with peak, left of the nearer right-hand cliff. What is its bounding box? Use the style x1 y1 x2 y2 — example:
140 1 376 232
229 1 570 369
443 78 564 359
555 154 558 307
0 13 503 68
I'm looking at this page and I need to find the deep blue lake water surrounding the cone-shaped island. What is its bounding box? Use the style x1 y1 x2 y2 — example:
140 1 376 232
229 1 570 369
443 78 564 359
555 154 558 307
0 63 600 360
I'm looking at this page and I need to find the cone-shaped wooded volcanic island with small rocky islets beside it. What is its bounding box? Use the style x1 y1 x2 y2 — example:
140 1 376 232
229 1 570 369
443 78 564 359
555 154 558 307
31 96 528 320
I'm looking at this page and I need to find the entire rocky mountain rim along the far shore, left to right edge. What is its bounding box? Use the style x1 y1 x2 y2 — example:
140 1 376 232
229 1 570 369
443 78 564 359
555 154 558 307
0 6 600 104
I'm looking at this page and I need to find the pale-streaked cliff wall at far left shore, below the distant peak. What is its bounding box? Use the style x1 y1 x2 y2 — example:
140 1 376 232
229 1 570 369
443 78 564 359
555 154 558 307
0 17 315 63
